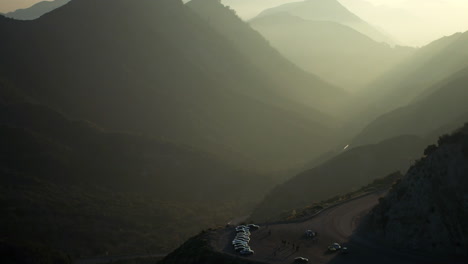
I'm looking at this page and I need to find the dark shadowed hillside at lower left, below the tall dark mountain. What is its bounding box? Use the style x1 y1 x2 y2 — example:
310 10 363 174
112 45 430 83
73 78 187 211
0 100 272 258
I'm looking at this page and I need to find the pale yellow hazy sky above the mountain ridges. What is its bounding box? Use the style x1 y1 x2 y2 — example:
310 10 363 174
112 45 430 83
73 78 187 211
0 0 468 46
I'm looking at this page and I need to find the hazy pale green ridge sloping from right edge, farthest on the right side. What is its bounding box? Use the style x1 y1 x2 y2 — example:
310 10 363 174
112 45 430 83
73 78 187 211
362 32 468 115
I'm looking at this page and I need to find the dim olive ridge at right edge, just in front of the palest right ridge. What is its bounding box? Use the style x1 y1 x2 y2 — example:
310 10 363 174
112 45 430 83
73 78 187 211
353 67 468 146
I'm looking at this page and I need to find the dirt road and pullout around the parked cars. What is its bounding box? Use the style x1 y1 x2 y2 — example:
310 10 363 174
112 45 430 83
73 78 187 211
213 192 462 264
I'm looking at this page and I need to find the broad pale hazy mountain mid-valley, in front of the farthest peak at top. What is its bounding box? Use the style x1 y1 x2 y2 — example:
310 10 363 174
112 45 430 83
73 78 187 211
249 12 414 91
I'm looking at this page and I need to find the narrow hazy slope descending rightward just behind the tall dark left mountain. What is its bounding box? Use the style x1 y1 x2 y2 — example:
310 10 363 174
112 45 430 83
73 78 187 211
187 0 349 114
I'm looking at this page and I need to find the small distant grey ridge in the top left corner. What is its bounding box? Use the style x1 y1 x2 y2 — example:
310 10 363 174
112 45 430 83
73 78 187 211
5 0 70 20
